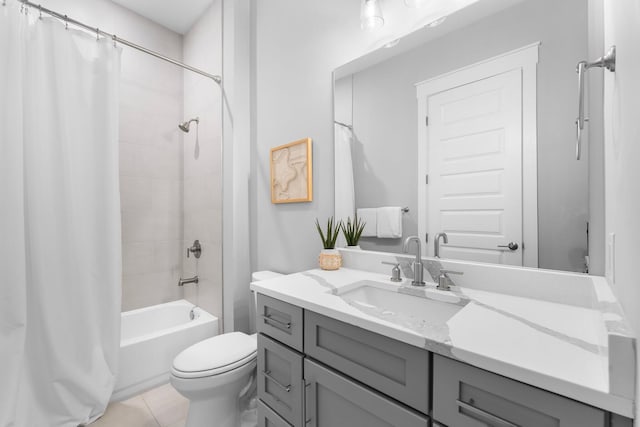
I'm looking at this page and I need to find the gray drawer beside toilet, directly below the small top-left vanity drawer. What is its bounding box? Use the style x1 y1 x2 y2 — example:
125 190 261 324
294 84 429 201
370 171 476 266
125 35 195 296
258 334 304 427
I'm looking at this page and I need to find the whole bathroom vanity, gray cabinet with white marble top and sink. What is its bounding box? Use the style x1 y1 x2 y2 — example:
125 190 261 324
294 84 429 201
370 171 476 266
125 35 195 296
252 251 633 427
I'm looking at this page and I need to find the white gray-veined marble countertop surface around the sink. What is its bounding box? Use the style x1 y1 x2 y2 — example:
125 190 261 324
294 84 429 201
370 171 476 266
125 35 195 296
251 268 634 417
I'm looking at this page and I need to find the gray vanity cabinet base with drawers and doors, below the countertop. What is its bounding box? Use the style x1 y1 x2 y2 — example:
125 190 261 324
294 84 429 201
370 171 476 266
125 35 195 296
257 295 632 427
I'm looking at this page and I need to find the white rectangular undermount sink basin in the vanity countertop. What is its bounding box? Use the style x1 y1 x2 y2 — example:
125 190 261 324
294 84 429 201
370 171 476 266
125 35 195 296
338 281 464 329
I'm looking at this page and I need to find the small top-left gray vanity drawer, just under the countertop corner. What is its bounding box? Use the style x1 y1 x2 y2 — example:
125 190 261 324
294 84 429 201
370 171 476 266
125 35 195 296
256 294 303 351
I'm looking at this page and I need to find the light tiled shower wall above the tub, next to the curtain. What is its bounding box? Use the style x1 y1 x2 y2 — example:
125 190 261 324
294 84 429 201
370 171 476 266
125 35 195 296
120 13 183 311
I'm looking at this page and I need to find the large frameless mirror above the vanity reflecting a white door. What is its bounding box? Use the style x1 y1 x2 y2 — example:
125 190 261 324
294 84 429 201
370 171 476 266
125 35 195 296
334 0 604 274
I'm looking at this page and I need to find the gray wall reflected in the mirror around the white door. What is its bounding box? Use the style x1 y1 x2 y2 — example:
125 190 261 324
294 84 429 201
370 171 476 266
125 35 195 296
336 0 589 271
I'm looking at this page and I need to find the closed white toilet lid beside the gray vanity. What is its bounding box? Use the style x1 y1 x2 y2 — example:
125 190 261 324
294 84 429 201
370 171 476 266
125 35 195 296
173 332 257 377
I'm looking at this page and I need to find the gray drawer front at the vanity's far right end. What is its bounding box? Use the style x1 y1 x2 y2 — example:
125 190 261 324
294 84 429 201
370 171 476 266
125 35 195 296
433 355 606 427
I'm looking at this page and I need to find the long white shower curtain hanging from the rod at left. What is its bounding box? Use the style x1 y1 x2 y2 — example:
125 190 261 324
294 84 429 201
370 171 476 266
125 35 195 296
0 1 121 427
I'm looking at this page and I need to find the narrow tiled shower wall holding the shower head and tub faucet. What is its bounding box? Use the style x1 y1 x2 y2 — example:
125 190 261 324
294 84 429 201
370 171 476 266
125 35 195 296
183 0 222 323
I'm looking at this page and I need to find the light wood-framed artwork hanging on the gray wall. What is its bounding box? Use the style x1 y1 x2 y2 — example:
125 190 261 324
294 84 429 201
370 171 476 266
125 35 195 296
271 138 313 203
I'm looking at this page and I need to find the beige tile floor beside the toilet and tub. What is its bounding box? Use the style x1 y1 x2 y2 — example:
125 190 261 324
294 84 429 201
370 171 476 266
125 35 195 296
90 384 257 427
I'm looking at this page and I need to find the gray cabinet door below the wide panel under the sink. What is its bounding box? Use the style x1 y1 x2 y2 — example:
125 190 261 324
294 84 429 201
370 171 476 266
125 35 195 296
304 359 429 427
